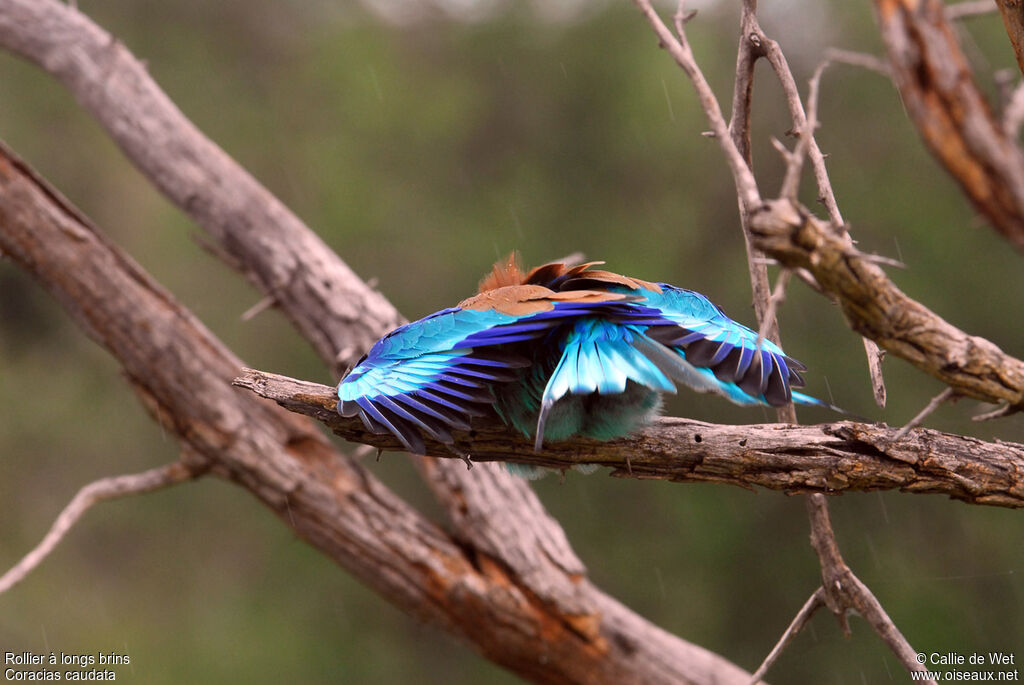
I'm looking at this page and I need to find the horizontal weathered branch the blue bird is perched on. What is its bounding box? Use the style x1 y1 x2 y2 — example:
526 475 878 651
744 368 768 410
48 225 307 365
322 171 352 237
234 369 1024 507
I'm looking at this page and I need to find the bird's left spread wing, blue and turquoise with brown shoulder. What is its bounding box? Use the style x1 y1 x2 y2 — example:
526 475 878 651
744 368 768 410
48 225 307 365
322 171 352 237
338 286 651 454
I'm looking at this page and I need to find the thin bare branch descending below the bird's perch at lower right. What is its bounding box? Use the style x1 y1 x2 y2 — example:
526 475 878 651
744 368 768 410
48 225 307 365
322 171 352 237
807 495 935 683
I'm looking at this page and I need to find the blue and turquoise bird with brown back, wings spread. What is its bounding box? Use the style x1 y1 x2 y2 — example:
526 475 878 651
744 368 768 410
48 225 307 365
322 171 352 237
337 253 846 465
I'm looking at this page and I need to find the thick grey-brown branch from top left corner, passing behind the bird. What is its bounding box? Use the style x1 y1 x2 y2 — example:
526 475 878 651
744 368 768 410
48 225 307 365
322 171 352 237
0 0 688 679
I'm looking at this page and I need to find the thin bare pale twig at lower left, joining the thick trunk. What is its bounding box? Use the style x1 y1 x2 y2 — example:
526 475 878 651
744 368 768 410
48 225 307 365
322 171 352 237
0 462 198 595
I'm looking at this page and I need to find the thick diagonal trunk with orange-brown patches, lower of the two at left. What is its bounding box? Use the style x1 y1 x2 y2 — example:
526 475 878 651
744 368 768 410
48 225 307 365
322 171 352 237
0 141 746 683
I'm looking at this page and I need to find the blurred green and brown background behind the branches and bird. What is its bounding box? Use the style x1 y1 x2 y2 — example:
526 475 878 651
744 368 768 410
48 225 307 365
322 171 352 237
0 0 1024 684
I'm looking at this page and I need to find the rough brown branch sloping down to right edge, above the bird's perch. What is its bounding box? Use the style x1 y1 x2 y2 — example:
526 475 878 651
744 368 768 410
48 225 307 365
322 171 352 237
752 201 1024 406
